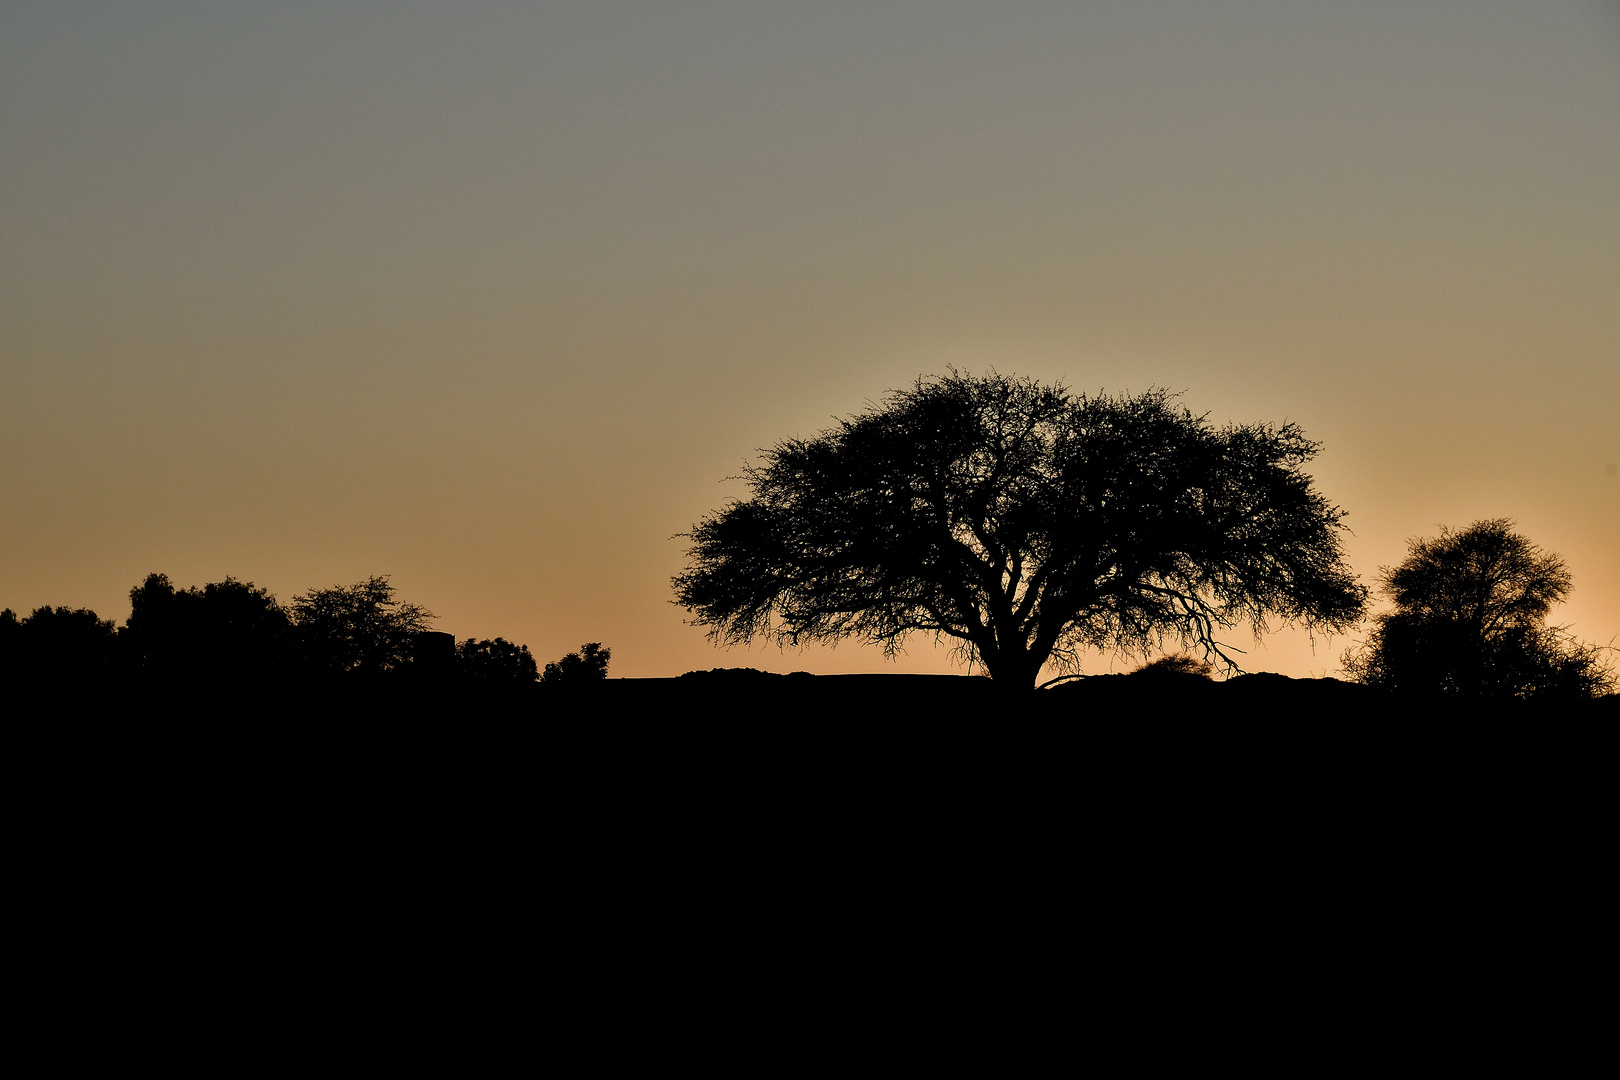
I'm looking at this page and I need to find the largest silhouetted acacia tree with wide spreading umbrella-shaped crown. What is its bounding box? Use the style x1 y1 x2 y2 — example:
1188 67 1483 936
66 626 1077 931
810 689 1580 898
674 371 1366 688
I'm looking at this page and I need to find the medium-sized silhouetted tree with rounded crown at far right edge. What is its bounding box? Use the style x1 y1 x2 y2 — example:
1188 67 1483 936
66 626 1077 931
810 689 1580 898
1345 518 1615 698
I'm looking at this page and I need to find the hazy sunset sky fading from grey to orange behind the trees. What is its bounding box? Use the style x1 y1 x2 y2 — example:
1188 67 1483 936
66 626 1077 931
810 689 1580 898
0 0 1620 677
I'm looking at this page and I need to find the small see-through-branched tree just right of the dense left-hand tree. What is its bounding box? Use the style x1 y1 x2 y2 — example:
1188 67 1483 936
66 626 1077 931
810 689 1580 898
292 576 434 674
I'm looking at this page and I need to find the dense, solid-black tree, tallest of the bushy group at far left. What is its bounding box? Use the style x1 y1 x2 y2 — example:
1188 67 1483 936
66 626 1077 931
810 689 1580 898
118 573 292 680
